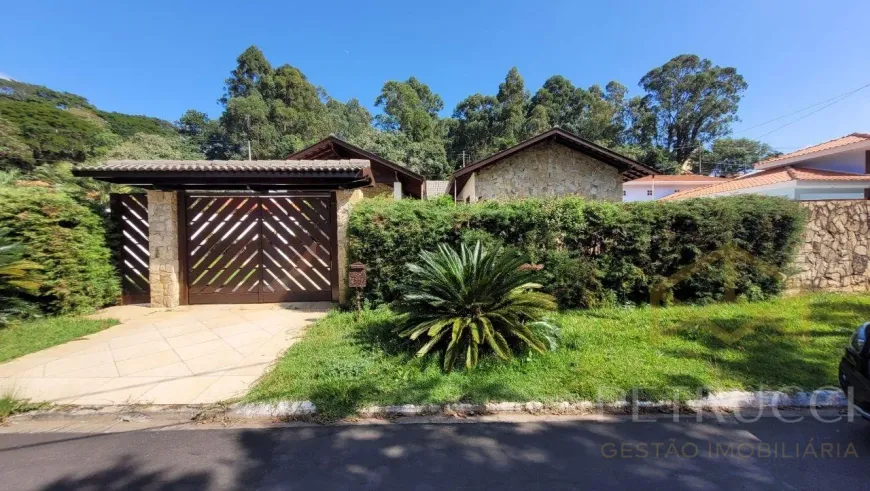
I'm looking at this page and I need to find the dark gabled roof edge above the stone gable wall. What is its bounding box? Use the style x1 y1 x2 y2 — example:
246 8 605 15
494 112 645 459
448 128 658 192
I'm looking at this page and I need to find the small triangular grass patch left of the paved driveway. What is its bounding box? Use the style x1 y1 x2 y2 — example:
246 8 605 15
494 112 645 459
0 317 118 363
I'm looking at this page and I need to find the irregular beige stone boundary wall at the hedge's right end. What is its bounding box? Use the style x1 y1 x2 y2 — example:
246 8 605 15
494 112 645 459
787 200 870 292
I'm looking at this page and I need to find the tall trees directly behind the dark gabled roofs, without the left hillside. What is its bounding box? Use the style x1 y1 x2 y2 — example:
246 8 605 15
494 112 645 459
184 46 764 178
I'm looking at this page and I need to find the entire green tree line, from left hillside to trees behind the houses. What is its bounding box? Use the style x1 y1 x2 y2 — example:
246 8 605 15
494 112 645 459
0 46 773 178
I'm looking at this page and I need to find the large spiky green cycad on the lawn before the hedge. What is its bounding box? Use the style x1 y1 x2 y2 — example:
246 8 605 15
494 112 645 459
396 242 558 372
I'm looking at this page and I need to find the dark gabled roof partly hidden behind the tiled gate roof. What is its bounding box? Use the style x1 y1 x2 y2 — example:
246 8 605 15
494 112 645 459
287 135 426 198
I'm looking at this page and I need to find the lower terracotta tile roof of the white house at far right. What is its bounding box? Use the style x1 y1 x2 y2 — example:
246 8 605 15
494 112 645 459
661 165 870 201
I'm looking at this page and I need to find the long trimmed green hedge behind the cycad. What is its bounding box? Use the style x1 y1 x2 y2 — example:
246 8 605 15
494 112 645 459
348 195 805 308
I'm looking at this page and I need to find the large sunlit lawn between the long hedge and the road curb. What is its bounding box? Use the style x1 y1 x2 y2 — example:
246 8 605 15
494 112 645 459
246 294 870 417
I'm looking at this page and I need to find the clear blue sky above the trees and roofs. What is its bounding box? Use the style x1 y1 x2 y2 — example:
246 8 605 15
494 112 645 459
0 0 870 151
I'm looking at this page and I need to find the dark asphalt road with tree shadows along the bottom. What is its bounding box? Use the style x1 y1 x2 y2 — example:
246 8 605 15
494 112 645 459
0 418 870 490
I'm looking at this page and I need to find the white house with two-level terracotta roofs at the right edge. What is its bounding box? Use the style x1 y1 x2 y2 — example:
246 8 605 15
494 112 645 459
662 133 870 201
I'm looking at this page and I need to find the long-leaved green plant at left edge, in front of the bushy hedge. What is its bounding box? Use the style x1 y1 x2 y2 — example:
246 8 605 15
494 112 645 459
0 230 40 327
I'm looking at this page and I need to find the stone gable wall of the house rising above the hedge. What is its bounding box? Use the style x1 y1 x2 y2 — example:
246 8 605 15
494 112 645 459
475 142 622 201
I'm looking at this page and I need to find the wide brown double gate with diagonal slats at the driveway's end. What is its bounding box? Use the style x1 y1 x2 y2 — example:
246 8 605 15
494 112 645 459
184 194 338 304
